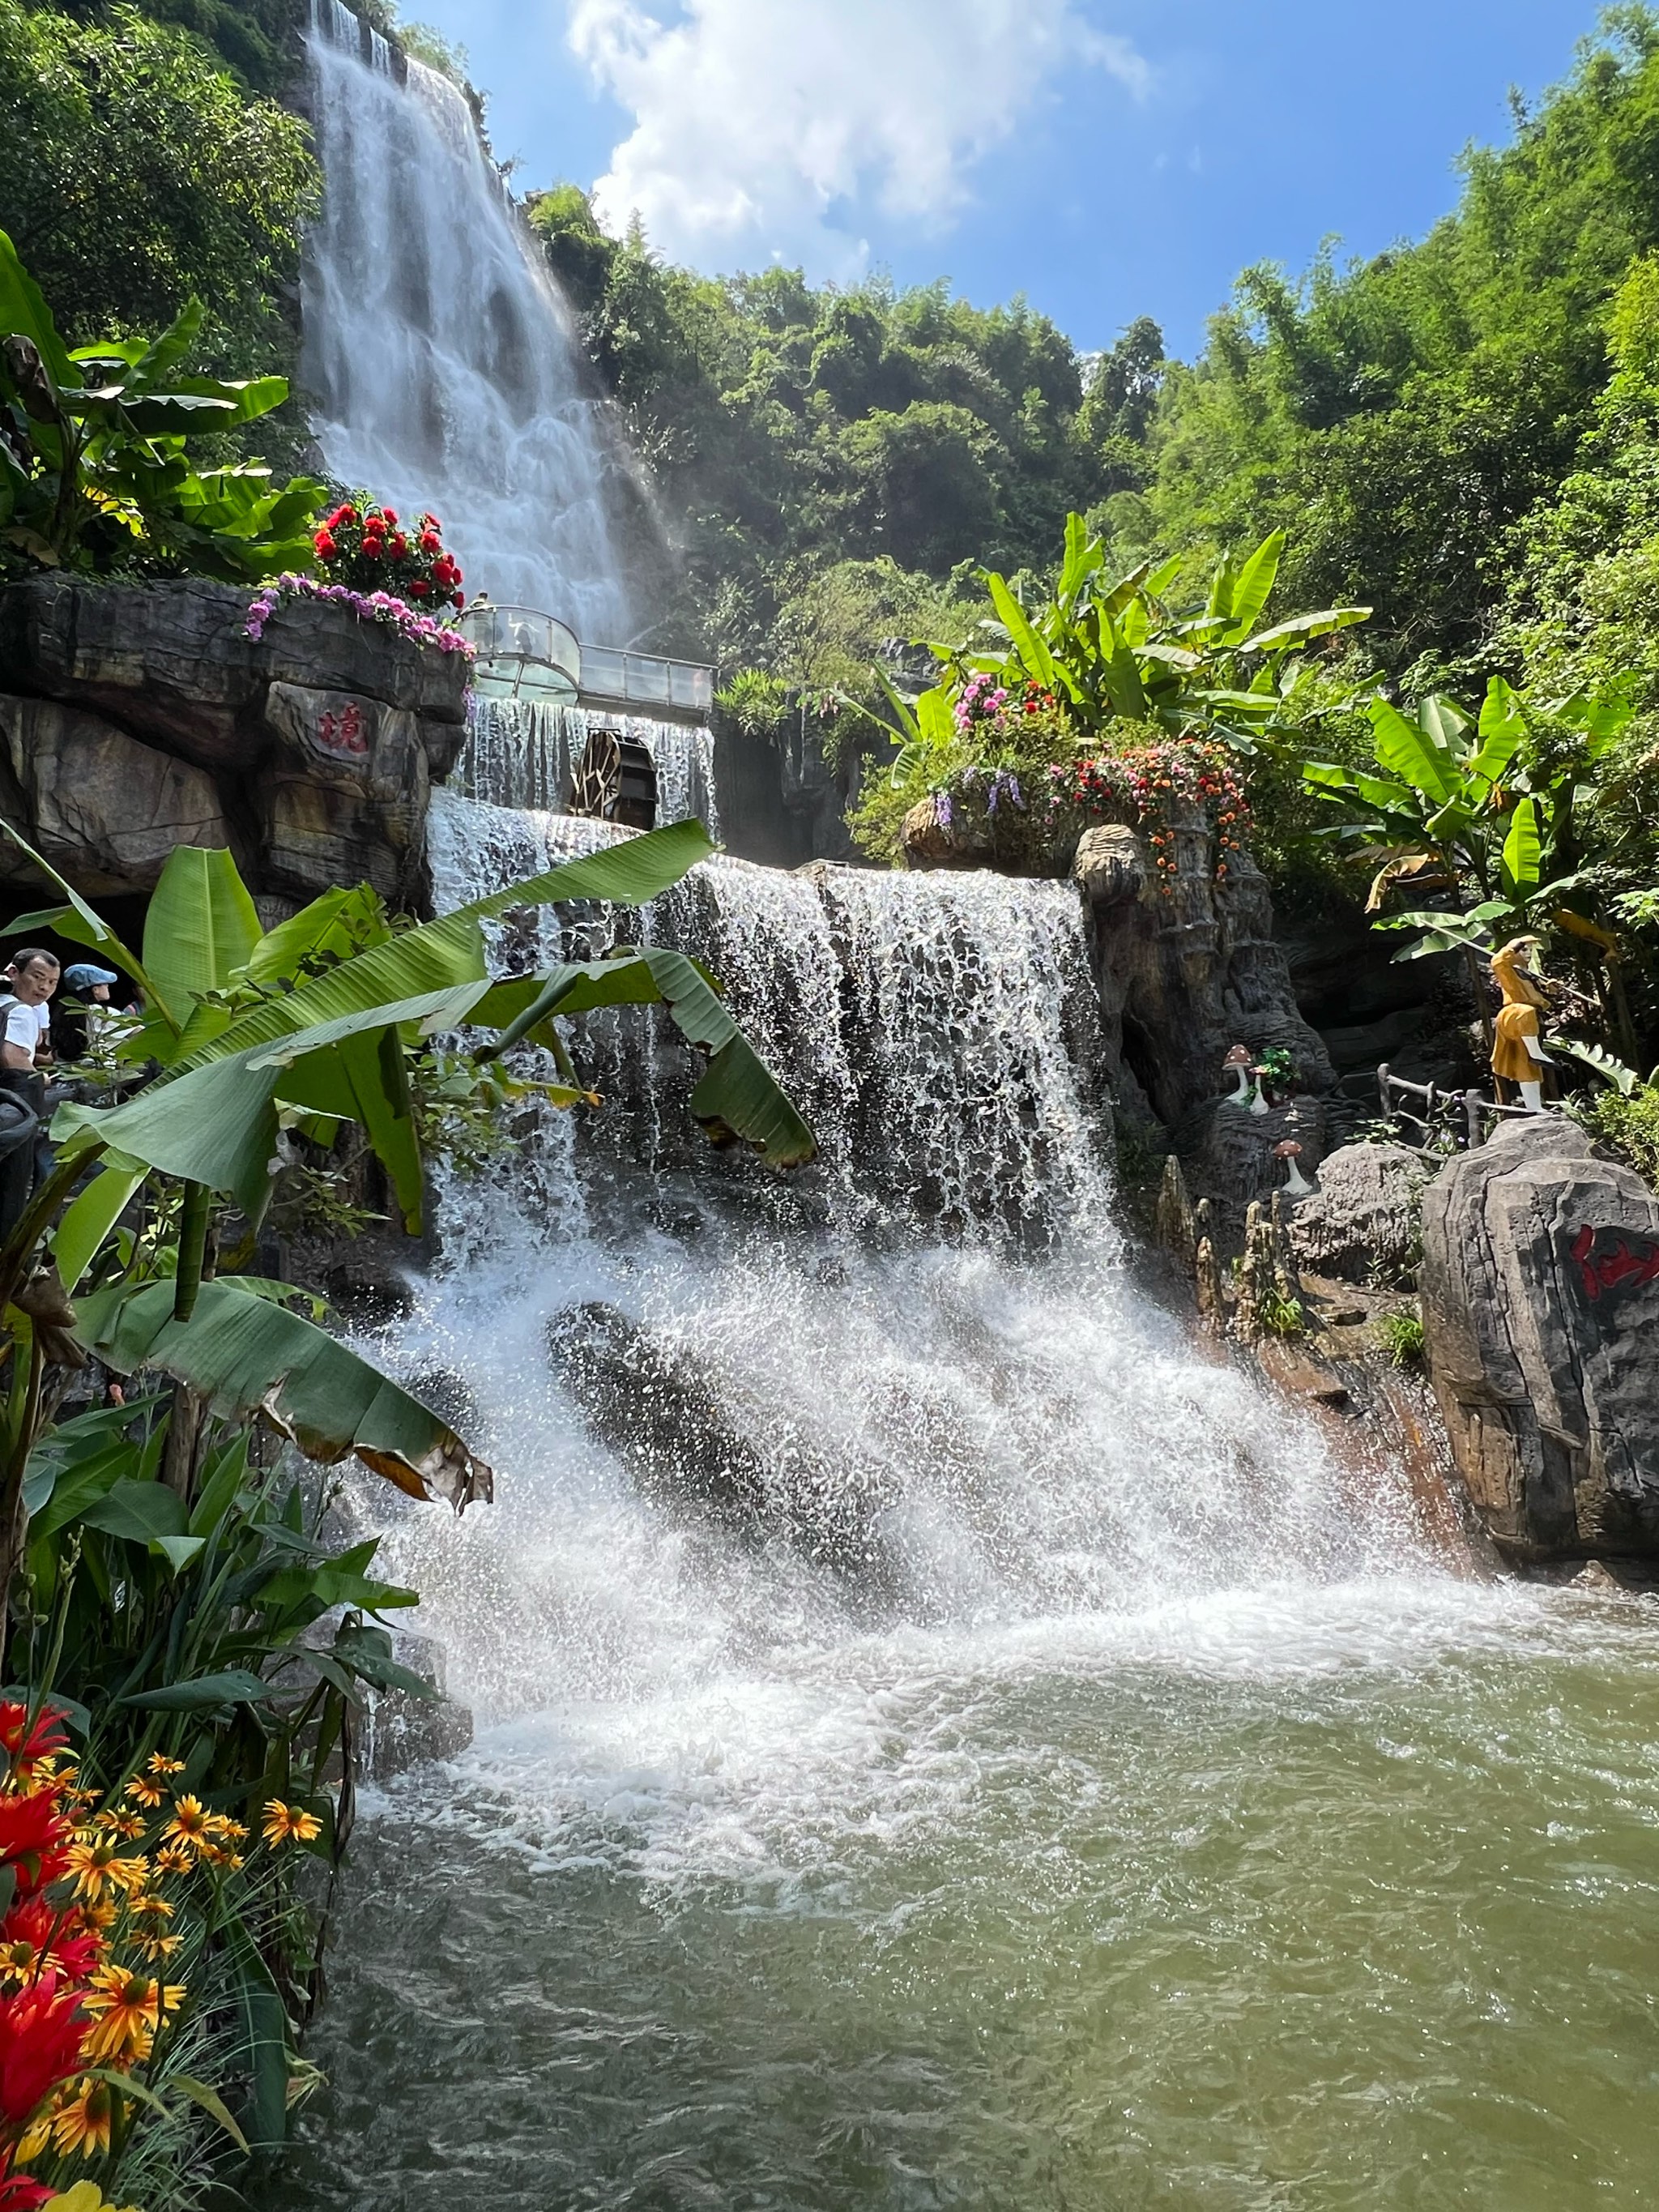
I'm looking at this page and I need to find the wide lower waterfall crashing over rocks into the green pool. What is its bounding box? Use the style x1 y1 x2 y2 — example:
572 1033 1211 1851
344 792 1427 1725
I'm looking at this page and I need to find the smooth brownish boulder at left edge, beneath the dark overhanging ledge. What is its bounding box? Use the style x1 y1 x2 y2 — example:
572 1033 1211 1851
0 697 232 898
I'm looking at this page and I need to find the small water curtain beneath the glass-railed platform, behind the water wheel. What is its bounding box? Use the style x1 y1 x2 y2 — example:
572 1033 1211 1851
449 697 719 836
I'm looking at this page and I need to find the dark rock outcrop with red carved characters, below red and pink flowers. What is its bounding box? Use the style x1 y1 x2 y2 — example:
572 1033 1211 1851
0 578 469 909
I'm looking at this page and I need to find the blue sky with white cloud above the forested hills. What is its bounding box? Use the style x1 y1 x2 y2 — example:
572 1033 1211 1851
405 0 1597 354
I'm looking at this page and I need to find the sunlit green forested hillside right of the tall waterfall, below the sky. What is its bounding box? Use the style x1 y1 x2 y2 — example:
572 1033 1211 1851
531 6 1659 725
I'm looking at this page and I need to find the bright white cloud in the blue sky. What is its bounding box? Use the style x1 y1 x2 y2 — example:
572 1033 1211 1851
569 0 1150 275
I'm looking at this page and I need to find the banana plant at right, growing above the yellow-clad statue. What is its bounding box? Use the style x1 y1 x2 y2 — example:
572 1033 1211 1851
1303 677 1632 960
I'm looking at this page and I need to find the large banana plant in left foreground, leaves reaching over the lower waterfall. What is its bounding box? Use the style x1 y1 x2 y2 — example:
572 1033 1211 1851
0 823 814 1628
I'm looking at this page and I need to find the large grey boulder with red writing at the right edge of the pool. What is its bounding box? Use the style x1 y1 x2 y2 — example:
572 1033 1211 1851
1422 1115 1659 1560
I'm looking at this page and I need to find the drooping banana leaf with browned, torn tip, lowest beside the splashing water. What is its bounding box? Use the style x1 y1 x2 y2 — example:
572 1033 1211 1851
78 1279 493 1511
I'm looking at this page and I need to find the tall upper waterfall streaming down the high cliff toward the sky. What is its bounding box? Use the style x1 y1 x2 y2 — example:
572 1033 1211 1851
303 0 633 642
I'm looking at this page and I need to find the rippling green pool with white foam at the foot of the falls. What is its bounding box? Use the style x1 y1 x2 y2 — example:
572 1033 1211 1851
281 1573 1659 2212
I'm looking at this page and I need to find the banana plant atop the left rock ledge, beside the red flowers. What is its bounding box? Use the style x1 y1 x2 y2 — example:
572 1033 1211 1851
0 230 327 582
